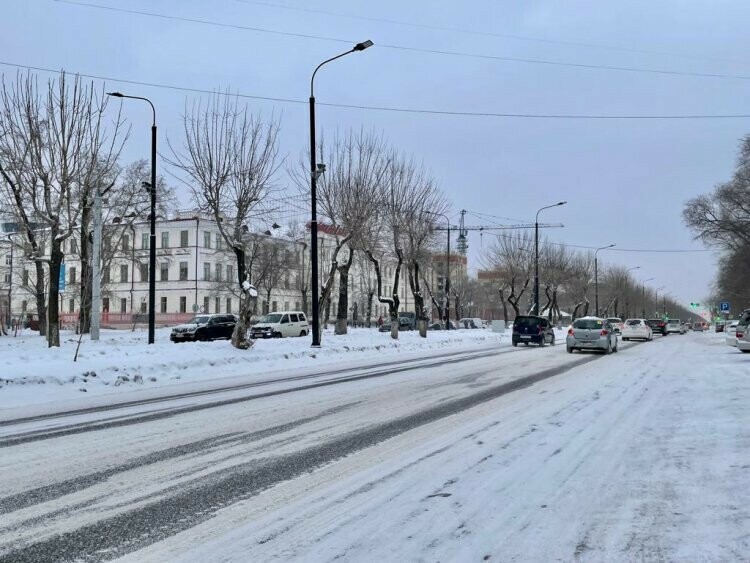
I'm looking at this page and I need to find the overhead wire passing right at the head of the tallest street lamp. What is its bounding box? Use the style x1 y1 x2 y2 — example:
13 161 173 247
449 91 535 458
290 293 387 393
55 0 750 80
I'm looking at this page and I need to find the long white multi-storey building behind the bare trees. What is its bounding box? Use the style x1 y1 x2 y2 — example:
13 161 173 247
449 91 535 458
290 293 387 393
0 212 414 327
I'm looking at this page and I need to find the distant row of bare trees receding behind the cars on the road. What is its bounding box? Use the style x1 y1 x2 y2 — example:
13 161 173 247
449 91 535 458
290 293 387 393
482 231 689 322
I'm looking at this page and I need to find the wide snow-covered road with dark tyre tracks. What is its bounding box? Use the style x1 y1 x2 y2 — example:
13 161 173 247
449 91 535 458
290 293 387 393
0 334 750 561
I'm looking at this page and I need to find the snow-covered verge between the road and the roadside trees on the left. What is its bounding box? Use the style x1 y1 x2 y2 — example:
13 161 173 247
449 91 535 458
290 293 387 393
0 329 509 411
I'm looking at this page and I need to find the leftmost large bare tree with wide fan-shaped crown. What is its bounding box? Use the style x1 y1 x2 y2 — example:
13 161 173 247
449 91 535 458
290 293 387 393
0 73 125 346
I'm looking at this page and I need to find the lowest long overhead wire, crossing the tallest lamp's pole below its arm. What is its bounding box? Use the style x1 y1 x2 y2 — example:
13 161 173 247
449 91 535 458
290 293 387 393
0 60 750 121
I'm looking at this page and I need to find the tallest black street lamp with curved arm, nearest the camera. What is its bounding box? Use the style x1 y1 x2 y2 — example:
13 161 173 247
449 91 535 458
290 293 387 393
310 39 373 347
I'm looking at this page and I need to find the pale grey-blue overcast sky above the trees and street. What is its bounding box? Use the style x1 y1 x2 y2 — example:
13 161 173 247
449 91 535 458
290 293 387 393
0 0 750 305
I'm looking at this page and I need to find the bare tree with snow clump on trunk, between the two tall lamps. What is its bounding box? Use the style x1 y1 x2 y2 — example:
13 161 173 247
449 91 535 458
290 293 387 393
170 95 281 349
